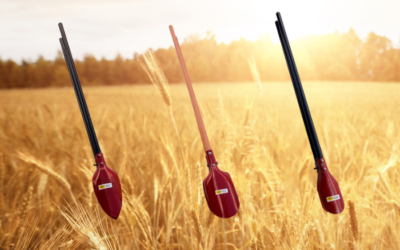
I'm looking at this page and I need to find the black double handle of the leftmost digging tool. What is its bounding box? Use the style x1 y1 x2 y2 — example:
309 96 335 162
58 23 101 155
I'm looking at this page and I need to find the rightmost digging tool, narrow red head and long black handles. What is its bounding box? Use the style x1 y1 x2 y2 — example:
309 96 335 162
275 12 344 214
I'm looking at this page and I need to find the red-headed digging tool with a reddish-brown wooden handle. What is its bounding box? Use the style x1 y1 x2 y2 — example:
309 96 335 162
169 25 240 218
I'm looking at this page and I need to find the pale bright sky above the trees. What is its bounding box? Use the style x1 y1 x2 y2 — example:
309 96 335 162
0 0 400 62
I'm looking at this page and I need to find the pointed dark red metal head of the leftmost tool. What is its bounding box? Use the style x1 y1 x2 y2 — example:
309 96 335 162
92 153 122 219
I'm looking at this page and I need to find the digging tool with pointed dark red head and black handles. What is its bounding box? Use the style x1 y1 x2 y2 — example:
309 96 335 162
58 23 122 219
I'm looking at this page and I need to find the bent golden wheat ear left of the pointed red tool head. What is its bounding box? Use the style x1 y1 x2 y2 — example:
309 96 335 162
17 152 77 204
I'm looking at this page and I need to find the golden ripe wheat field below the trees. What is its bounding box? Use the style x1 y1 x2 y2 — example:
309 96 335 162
0 82 400 250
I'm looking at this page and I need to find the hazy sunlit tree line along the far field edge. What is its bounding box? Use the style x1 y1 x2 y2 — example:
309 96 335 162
0 29 400 88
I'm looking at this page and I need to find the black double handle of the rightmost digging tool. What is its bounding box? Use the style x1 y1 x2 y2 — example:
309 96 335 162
275 12 323 159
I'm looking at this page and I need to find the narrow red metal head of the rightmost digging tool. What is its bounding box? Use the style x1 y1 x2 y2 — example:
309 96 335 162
316 158 344 214
